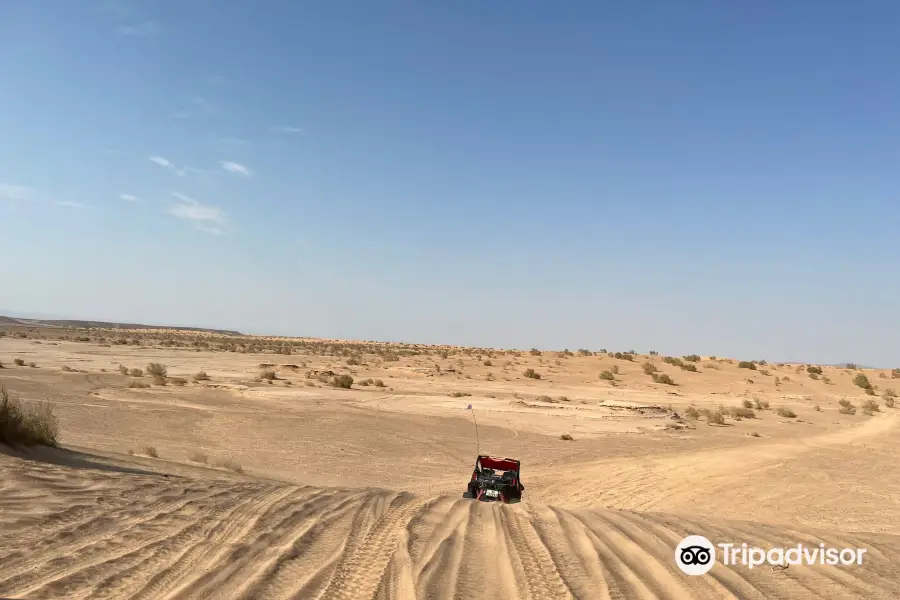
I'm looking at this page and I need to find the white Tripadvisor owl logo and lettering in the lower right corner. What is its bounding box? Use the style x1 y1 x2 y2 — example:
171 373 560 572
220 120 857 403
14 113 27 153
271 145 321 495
675 535 866 575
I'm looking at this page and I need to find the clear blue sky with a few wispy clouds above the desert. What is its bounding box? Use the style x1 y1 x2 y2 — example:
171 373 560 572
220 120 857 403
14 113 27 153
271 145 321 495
0 0 900 367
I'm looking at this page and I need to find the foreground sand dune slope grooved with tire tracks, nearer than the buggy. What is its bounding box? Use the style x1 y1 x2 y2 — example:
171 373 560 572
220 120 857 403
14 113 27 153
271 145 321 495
0 454 900 600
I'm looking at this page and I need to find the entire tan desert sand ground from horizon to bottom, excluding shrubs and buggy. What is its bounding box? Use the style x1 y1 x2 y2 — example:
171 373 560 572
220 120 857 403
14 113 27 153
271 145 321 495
0 326 900 600
